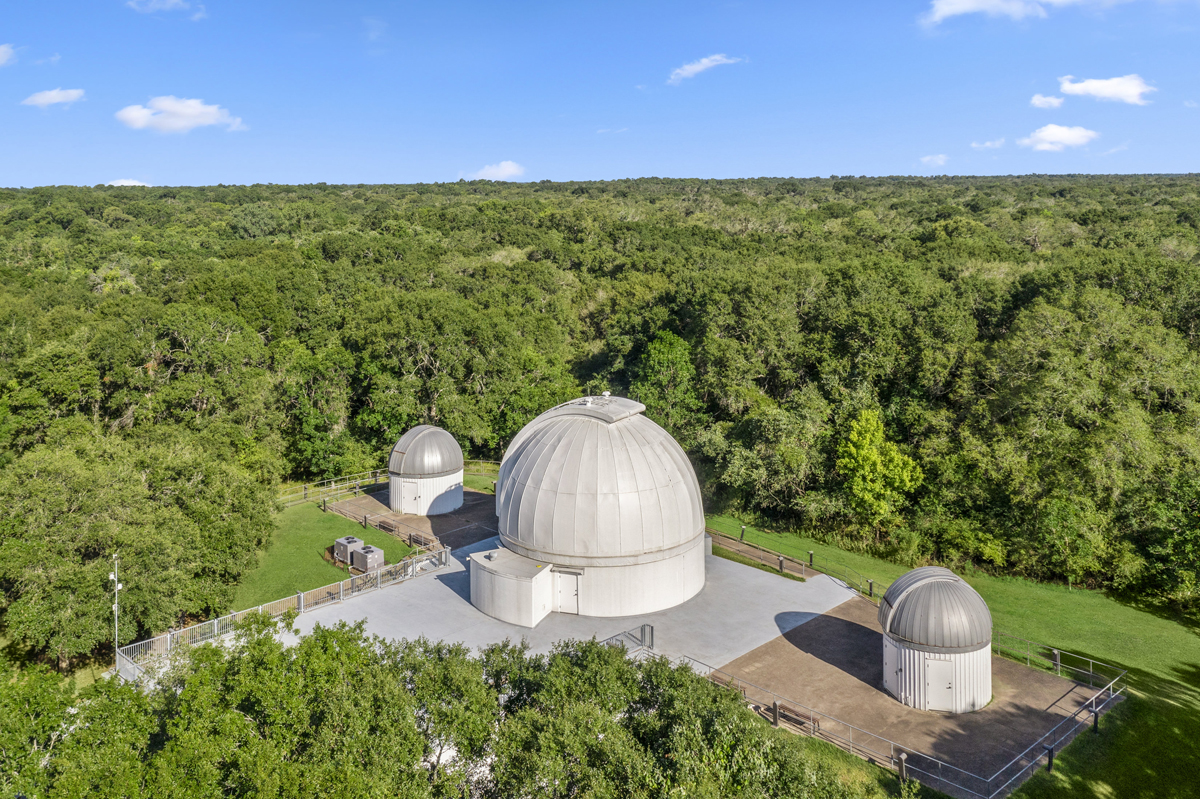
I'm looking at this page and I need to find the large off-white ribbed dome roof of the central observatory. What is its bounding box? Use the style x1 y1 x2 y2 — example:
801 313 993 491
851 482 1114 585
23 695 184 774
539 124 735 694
496 397 704 566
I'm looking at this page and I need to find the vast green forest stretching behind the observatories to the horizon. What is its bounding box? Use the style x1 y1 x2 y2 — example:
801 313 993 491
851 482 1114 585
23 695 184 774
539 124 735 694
0 176 1200 667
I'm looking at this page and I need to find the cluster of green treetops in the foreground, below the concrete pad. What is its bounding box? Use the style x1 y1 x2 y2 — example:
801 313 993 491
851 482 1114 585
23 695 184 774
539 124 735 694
0 619 883 799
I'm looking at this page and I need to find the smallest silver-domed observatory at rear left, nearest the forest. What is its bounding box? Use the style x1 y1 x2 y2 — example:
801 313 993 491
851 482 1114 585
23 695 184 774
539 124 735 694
388 425 463 516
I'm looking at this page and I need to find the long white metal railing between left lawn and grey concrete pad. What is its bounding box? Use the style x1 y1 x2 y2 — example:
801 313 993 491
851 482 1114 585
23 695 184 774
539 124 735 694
116 547 450 680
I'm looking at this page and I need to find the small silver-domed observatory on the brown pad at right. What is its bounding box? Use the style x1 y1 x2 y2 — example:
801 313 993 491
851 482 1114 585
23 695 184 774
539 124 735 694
880 566 991 713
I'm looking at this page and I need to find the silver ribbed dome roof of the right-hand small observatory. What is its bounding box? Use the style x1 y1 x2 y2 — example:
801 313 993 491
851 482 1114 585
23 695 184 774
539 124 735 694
880 566 991 653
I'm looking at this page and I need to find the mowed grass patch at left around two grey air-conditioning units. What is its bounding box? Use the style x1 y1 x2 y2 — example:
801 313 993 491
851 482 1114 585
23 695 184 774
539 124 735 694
234 503 412 611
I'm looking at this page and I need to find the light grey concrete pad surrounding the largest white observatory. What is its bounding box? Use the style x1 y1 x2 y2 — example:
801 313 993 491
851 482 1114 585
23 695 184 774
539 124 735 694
285 537 854 666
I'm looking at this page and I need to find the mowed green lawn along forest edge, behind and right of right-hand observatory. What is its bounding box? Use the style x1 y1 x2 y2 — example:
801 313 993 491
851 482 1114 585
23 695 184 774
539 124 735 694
708 516 1200 799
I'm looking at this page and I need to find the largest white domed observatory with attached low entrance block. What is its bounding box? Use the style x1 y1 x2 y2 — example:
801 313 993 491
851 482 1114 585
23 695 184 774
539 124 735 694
470 395 709 627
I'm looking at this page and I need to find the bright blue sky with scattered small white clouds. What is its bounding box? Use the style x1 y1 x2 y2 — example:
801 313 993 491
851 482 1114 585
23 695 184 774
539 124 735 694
0 0 1200 186
